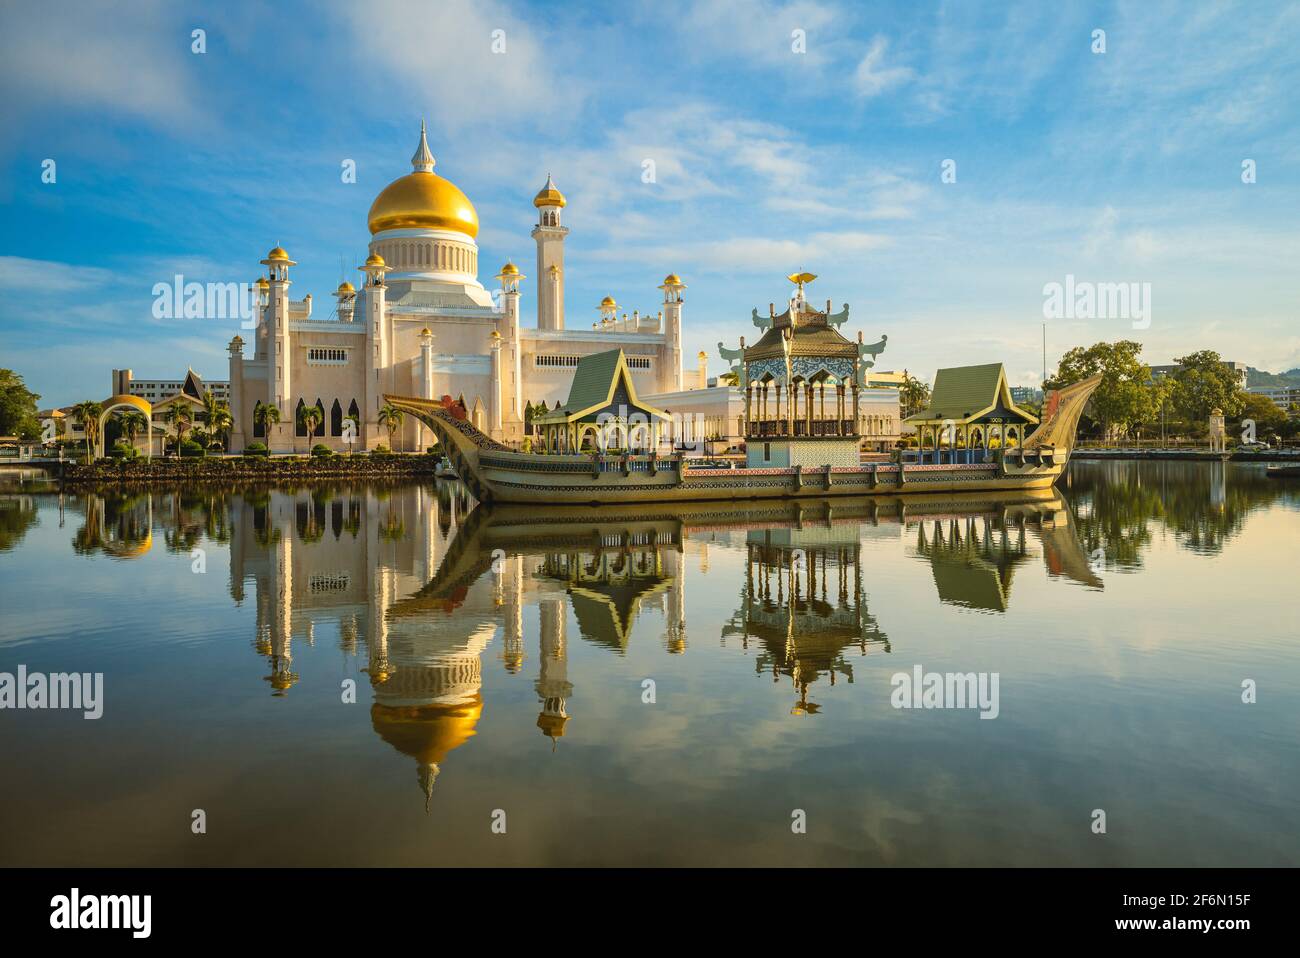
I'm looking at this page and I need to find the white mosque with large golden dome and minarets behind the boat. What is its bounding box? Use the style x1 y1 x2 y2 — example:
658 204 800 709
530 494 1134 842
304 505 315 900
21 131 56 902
229 125 691 452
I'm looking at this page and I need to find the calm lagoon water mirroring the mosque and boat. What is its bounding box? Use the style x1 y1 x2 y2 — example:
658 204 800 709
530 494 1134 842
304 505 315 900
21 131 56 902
0 463 1300 866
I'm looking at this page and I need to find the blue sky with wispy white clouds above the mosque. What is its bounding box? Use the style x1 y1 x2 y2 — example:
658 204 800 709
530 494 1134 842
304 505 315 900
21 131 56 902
0 0 1300 406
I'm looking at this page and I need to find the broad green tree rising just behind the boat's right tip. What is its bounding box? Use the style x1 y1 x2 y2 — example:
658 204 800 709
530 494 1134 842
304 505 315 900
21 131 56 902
1043 339 1160 439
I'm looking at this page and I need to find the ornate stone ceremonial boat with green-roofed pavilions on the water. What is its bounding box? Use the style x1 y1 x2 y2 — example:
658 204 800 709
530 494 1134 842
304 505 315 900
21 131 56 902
385 273 1101 506
